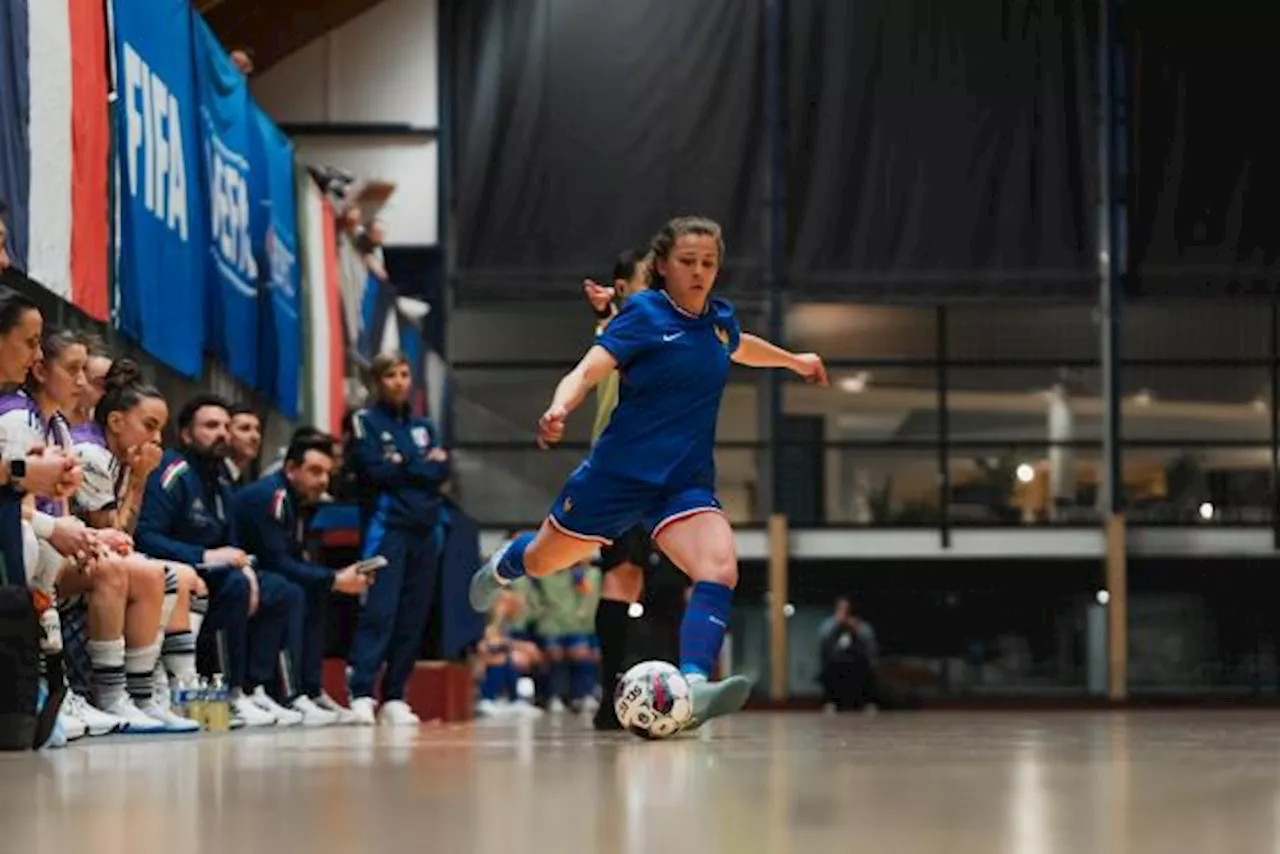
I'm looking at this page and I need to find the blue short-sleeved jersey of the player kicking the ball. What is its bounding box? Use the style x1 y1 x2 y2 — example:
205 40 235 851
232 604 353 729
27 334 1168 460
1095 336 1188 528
589 291 742 484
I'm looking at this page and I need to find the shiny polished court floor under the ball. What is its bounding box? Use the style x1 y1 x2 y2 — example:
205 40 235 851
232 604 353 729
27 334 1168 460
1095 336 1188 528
0 711 1280 854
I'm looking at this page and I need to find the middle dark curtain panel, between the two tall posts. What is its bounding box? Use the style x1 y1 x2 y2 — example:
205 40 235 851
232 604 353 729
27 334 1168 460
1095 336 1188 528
788 0 1098 301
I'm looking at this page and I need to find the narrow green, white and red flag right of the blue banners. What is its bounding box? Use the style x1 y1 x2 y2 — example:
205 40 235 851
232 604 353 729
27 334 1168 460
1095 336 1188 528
294 166 346 435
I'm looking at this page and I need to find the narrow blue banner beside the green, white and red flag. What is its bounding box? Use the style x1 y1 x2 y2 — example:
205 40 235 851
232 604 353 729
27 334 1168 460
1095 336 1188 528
251 105 302 420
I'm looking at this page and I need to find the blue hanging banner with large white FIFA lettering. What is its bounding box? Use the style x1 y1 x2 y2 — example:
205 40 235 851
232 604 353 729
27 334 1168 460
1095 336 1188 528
111 0 209 376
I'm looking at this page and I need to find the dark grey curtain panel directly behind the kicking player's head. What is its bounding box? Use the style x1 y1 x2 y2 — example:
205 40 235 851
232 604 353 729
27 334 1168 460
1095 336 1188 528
444 0 763 301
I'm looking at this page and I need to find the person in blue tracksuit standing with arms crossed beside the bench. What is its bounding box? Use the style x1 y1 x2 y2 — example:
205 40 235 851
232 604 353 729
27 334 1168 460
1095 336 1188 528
348 353 449 725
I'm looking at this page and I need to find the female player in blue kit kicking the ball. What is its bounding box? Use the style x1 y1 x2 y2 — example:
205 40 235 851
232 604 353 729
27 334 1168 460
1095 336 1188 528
470 216 827 727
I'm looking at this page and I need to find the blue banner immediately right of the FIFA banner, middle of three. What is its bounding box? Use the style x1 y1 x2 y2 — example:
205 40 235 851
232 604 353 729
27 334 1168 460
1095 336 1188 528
190 15 258 385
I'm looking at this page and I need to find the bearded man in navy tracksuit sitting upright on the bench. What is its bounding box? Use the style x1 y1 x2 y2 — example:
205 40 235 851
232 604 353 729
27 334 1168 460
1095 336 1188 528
134 394 303 726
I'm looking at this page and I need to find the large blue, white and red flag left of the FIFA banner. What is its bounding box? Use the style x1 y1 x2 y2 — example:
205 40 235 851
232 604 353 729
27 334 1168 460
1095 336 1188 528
0 0 111 320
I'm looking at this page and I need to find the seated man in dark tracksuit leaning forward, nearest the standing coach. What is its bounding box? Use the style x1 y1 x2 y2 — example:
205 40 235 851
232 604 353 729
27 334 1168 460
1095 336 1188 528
234 431 369 725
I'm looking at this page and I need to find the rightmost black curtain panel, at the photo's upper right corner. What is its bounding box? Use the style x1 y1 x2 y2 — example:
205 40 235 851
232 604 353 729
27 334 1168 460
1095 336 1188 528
1125 0 1280 297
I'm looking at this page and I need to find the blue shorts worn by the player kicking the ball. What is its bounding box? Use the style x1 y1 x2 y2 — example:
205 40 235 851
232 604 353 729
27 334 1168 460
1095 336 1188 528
549 462 721 545
